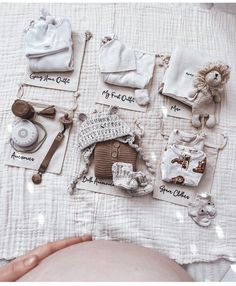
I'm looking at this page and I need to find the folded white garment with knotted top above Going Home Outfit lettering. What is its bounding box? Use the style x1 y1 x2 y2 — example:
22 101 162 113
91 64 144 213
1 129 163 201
25 10 73 72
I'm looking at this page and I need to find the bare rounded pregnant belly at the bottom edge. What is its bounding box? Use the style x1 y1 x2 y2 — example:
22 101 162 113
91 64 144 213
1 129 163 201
18 240 192 282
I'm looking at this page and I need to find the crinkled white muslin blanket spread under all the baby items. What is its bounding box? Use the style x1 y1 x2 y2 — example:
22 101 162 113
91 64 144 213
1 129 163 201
0 3 236 263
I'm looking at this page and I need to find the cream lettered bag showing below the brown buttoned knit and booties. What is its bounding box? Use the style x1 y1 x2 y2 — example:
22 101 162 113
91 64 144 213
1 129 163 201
76 163 130 197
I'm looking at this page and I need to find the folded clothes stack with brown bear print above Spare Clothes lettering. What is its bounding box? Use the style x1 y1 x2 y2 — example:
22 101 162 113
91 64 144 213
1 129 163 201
161 130 206 187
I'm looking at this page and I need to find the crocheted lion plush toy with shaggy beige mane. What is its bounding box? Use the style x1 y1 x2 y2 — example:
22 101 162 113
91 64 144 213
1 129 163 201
189 62 230 128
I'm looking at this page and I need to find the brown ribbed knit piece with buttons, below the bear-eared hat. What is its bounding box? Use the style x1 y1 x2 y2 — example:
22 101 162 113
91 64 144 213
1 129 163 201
94 140 137 179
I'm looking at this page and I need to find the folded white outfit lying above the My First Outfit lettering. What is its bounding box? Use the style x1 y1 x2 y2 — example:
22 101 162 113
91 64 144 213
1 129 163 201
99 35 155 105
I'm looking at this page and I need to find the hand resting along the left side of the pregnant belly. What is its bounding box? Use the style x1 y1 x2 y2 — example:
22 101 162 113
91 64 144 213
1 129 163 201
0 235 92 282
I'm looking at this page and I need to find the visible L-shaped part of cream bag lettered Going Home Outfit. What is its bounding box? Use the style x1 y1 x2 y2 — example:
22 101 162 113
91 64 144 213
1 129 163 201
24 33 86 91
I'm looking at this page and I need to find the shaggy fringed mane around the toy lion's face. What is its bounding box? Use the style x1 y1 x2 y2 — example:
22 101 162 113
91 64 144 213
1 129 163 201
194 62 230 90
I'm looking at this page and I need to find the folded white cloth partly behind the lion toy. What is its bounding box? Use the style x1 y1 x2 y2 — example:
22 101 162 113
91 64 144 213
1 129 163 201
162 48 214 106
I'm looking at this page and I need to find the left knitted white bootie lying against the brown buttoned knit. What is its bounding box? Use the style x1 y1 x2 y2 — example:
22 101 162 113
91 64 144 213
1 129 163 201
112 162 138 190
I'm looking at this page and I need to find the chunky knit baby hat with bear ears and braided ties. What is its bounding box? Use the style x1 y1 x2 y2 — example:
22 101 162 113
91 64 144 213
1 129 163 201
69 106 155 194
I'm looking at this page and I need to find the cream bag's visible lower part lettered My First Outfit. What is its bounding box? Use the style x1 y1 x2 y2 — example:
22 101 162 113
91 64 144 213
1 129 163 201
96 79 147 112
